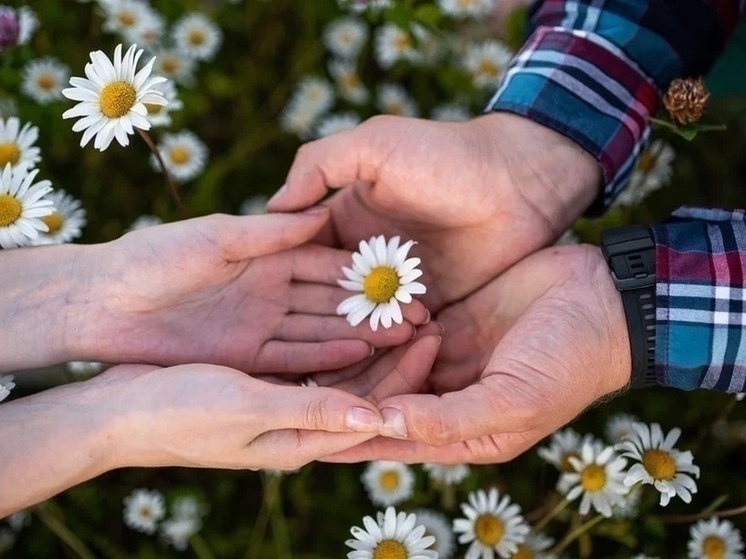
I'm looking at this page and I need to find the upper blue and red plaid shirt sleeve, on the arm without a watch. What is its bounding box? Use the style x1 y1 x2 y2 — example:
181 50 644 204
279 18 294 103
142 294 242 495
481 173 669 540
486 0 739 213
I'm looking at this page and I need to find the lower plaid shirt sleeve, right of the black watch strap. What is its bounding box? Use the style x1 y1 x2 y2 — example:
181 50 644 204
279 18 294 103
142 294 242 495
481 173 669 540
651 207 746 392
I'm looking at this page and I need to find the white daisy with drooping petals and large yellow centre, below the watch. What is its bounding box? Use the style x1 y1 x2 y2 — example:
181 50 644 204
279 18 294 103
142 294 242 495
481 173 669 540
616 423 699 507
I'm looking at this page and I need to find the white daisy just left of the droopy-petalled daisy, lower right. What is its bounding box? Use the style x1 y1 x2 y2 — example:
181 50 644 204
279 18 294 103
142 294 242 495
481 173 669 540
561 442 629 517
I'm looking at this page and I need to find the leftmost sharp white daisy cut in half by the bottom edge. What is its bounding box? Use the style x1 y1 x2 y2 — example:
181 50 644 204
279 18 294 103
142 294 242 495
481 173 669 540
345 507 438 559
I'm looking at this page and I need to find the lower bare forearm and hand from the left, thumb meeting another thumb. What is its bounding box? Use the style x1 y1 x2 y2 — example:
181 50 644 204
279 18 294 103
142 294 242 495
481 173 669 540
0 325 440 518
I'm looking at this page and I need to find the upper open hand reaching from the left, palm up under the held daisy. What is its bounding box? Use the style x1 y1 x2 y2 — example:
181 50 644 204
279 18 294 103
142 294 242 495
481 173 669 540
76 208 428 373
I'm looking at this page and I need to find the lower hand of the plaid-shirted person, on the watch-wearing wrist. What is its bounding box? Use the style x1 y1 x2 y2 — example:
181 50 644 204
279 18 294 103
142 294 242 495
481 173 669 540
324 245 631 463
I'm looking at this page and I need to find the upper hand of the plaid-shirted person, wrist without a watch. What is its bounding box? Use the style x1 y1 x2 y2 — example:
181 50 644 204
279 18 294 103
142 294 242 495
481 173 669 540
268 113 601 310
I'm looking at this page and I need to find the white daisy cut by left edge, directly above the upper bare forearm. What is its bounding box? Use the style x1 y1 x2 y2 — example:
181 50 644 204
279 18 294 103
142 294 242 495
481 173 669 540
0 164 54 248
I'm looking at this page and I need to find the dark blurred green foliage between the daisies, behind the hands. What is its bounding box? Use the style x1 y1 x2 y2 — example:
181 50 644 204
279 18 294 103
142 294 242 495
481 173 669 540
0 0 746 559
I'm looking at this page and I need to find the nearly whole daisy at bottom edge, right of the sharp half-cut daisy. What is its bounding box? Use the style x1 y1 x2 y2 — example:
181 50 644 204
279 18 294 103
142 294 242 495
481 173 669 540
453 487 529 559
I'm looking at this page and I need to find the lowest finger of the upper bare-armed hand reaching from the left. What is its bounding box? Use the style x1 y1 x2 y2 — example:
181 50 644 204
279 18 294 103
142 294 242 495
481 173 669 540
252 340 373 373
